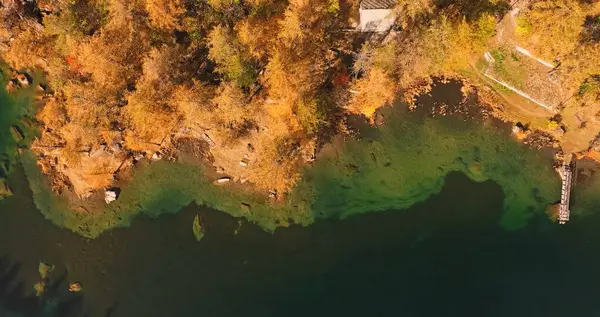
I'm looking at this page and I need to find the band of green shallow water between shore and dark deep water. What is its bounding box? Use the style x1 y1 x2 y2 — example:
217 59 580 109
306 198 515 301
2 79 576 238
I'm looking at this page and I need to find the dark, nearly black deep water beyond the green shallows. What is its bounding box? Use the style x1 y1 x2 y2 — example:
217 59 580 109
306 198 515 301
0 162 600 317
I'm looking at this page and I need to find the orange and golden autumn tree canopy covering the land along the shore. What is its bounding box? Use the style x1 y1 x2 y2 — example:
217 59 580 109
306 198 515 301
0 0 600 197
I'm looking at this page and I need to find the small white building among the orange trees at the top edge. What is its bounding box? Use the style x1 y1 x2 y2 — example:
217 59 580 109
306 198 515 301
358 0 396 33
